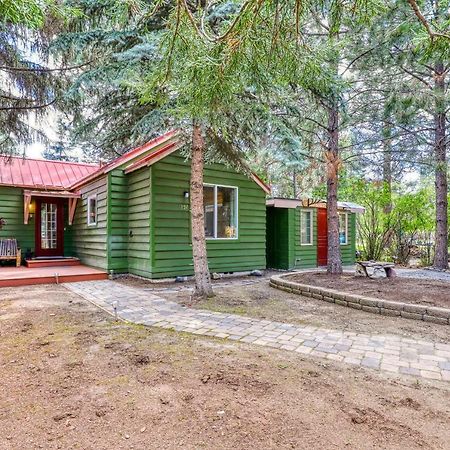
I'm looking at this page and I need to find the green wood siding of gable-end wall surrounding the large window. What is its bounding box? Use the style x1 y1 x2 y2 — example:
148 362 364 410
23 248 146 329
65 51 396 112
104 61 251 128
151 152 266 278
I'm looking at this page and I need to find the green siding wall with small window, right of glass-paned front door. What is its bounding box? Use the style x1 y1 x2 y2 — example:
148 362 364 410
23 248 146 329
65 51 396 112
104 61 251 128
64 176 108 269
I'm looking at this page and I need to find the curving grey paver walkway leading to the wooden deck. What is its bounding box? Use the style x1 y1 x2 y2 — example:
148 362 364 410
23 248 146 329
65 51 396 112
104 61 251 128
65 280 450 381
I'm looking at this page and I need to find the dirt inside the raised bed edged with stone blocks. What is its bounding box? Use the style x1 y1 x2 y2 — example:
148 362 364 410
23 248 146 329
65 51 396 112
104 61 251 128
288 272 450 308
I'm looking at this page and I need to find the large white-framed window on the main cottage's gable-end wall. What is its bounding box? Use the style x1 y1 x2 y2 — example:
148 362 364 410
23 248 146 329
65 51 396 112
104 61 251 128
203 184 238 239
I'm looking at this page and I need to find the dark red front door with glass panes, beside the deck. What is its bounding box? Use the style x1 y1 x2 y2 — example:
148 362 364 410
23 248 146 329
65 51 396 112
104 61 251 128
36 198 64 257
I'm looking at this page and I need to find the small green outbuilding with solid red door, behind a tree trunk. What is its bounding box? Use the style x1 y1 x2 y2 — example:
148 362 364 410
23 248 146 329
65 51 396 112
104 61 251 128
267 198 364 270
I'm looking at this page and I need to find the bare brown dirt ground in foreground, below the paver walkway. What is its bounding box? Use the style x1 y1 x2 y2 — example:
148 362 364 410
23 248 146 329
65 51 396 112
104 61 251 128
0 286 450 450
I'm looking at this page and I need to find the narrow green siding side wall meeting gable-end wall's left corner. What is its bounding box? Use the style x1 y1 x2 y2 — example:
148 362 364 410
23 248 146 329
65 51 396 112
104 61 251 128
128 167 152 277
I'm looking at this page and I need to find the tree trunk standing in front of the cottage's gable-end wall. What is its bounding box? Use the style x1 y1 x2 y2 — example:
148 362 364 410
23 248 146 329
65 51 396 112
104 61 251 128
191 120 213 297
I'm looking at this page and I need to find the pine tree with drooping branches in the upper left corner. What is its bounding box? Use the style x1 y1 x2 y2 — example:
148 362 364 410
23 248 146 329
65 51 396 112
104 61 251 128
0 0 73 154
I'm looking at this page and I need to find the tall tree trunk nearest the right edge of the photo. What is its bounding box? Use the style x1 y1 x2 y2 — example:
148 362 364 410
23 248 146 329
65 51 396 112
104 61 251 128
433 62 448 269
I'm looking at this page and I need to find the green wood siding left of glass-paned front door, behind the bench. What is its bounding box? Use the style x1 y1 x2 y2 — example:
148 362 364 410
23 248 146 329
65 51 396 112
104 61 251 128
0 187 35 257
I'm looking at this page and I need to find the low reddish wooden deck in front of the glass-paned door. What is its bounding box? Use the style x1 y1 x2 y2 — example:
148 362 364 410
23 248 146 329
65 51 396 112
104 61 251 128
0 265 108 287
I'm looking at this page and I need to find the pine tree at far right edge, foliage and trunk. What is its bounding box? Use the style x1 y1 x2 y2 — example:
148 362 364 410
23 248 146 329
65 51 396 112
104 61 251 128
366 0 450 269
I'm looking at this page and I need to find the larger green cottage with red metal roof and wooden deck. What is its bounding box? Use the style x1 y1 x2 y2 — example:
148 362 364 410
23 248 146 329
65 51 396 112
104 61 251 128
0 131 270 278
